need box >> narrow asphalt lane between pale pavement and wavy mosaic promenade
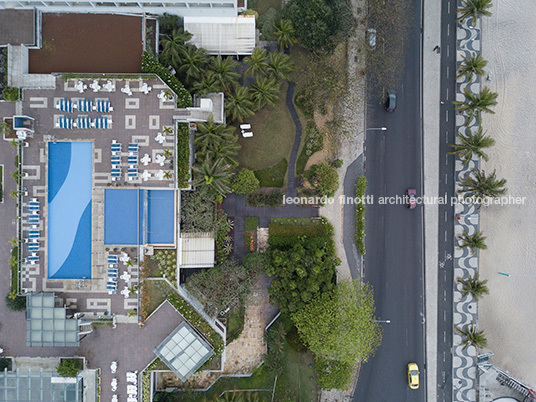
[437,0,456,402]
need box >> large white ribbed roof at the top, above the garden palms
[184,15,255,56]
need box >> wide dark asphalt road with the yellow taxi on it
[354,1,426,402]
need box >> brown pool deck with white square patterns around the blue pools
[16,77,180,314]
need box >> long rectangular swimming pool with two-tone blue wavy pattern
[48,142,93,279]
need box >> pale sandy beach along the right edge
[479,0,536,387]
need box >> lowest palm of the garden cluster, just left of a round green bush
[193,155,231,196]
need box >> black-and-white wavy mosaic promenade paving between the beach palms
[452,9,482,402]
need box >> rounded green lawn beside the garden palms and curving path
[237,82,296,170]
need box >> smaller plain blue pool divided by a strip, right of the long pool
[104,189,175,245]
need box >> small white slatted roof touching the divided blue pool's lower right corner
[181,232,215,268]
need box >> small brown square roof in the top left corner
[0,10,35,46]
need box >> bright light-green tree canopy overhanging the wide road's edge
[291,280,382,365]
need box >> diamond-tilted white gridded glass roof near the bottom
[154,321,214,381]
